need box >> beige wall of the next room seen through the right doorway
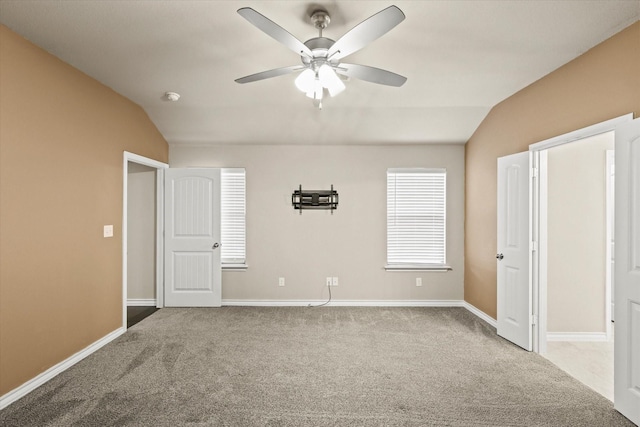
[547,132,614,333]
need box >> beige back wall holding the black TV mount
[169,145,464,301]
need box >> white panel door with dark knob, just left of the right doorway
[496,152,532,351]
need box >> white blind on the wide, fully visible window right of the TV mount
[387,169,447,267]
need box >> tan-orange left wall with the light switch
[0,26,168,395]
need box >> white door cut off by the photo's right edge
[614,119,640,425]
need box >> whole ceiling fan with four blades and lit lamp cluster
[236,6,407,108]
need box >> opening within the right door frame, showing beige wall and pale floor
[541,131,614,400]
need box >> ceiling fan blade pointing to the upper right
[327,6,404,60]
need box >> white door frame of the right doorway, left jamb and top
[529,113,633,354]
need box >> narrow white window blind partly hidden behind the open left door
[220,169,246,265]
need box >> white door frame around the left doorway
[122,151,169,329]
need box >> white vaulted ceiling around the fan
[0,0,640,145]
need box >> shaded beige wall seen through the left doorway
[127,162,156,299]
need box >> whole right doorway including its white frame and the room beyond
[530,115,631,400]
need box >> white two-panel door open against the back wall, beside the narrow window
[164,169,222,307]
